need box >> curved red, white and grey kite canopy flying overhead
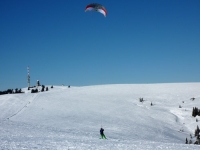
[85,3,107,17]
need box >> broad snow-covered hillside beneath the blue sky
[0,83,200,150]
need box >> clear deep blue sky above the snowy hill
[0,0,200,90]
